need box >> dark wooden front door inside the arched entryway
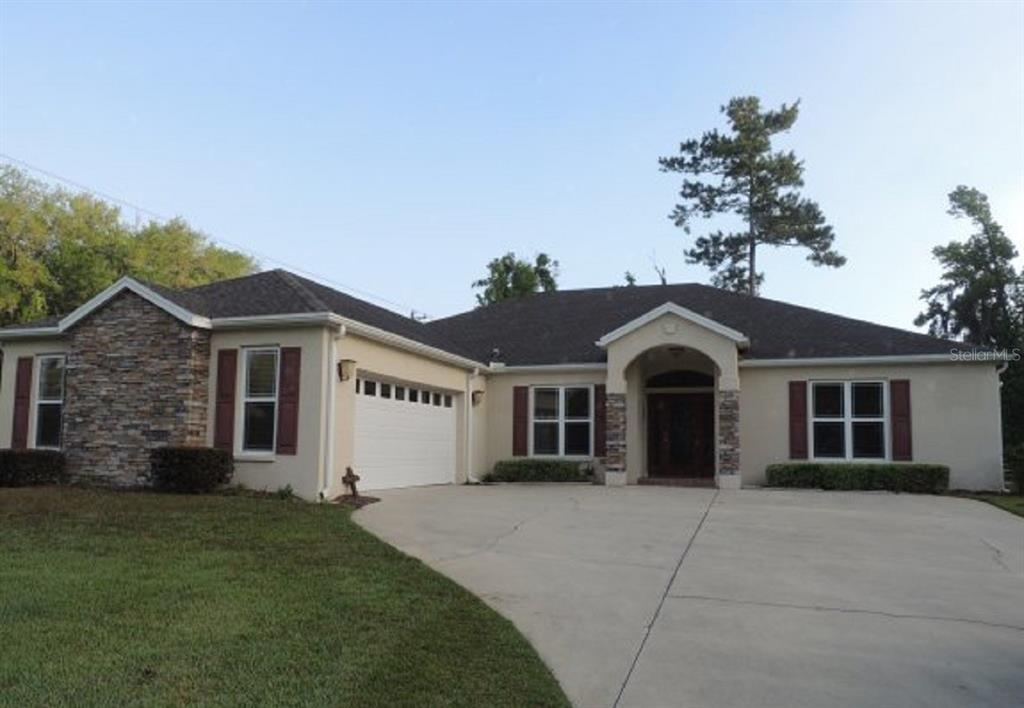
[647,392,715,477]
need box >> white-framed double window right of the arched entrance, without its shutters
[811,381,887,460]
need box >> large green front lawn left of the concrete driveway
[0,488,568,706]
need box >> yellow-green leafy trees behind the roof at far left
[0,165,257,325]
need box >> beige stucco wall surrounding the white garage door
[330,334,486,494]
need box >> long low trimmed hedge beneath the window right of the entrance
[767,462,949,494]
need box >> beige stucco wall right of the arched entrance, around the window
[739,363,1002,489]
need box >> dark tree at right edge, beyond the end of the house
[914,185,1024,447]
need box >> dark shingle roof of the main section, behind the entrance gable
[421,283,949,366]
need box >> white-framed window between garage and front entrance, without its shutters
[530,386,594,456]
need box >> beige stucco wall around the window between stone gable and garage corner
[207,327,330,499]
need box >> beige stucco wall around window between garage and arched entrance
[474,370,605,474]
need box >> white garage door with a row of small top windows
[354,380,456,490]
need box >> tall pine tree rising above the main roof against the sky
[658,96,846,295]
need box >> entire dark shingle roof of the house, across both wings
[5,269,950,366]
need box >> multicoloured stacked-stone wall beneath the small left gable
[62,292,210,486]
